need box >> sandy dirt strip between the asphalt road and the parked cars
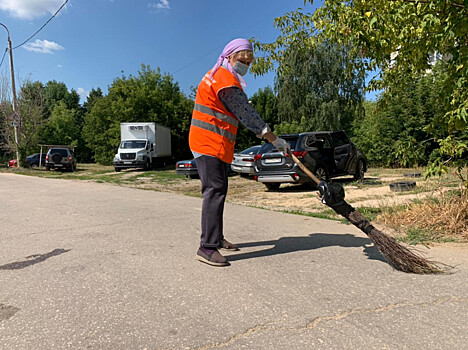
[125,174,458,213]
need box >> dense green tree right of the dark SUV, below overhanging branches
[355,71,443,167]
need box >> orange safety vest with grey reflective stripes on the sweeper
[189,67,242,163]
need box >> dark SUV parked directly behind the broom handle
[254,131,367,190]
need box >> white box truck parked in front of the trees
[113,123,171,171]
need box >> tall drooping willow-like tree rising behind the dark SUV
[275,38,364,132]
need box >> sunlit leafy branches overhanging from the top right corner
[256,0,468,186]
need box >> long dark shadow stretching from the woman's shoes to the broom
[225,233,385,262]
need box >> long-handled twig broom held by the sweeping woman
[288,152,447,274]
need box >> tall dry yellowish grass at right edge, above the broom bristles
[378,191,468,242]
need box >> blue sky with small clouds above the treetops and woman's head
[0,0,376,102]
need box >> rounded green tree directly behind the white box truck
[83,65,193,164]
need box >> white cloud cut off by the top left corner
[0,0,64,19]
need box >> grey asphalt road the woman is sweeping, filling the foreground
[0,174,468,350]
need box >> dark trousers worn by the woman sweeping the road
[195,156,228,248]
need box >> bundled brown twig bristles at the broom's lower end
[333,203,448,274]
